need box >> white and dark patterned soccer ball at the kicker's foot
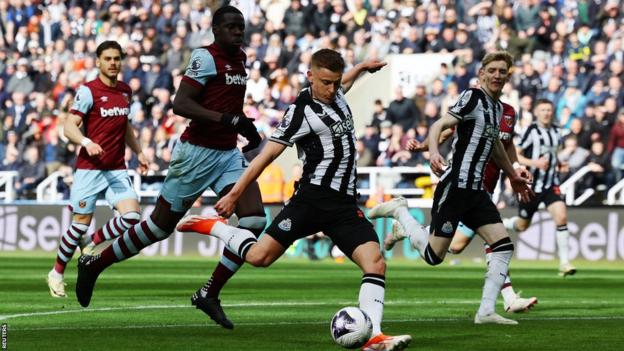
[331,307,373,349]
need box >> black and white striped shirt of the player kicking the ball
[270,88,356,196]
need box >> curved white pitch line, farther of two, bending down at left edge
[0,300,613,321]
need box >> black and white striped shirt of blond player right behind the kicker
[441,89,503,190]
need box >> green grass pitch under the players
[0,252,624,351]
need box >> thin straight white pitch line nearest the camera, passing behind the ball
[11,316,624,332]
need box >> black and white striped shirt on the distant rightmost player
[520,122,562,193]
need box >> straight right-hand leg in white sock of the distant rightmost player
[544,190,576,277]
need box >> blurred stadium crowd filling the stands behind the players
[0,0,624,202]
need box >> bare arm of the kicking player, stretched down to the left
[214,141,286,218]
